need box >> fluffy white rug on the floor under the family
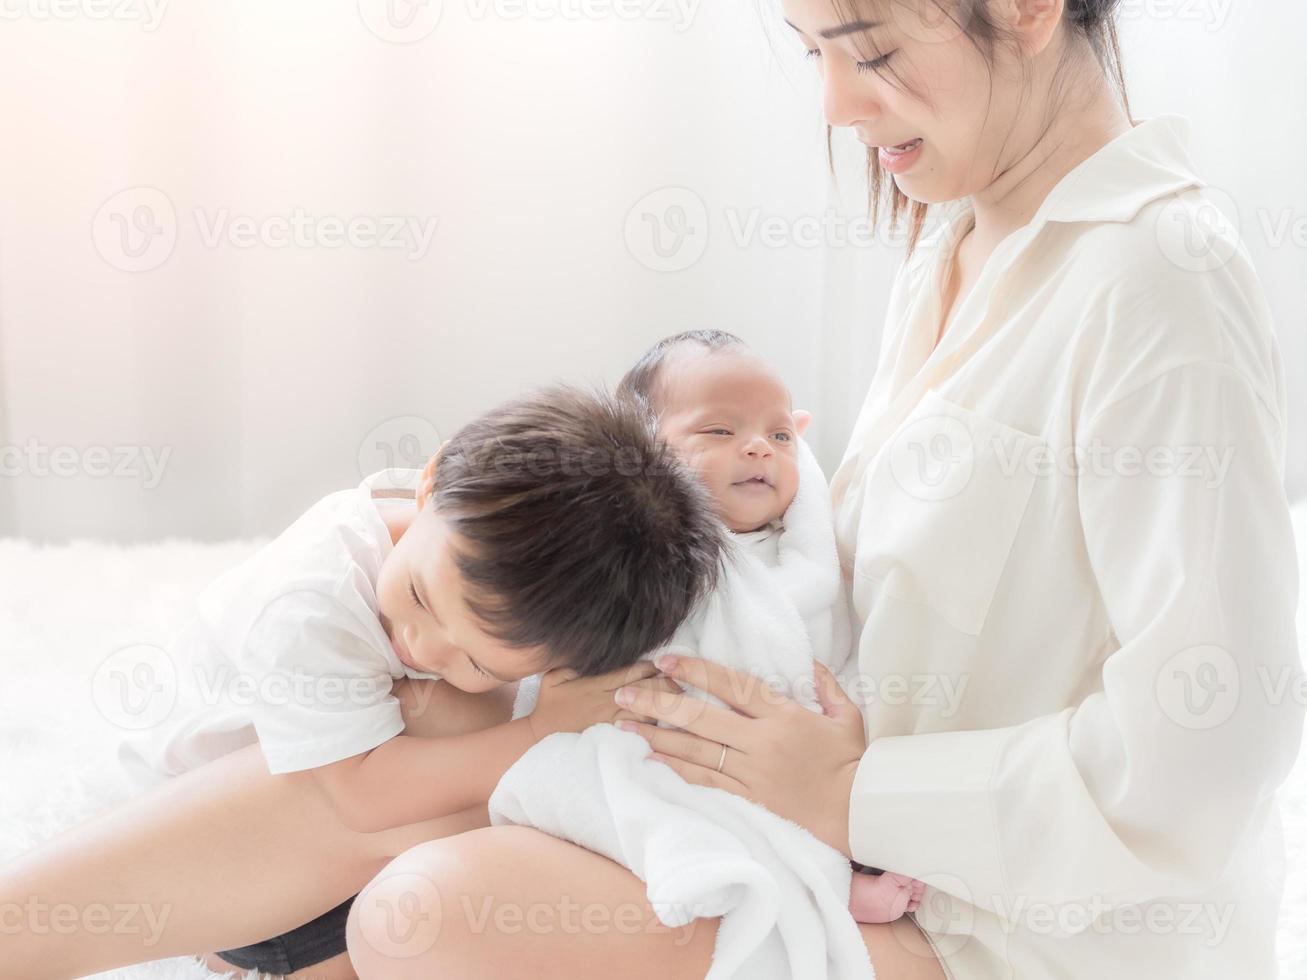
[0,514,1307,980]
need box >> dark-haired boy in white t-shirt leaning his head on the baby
[0,387,720,977]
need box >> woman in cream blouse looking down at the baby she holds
[349,0,1302,980]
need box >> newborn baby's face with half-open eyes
[659,348,809,532]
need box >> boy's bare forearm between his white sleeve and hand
[312,717,536,834]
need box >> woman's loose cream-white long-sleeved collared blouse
[831,116,1303,980]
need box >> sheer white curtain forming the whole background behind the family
[0,0,1307,541]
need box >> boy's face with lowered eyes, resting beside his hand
[376,498,549,694]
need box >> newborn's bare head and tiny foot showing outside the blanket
[617,331,924,923]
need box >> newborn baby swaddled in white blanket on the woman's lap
[490,331,923,961]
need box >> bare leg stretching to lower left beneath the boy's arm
[0,681,508,980]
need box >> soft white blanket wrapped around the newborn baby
[490,440,874,980]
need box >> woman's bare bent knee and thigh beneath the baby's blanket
[348,827,945,980]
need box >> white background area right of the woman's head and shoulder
[1121,0,1307,497]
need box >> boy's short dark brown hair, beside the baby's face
[433,385,721,676]
